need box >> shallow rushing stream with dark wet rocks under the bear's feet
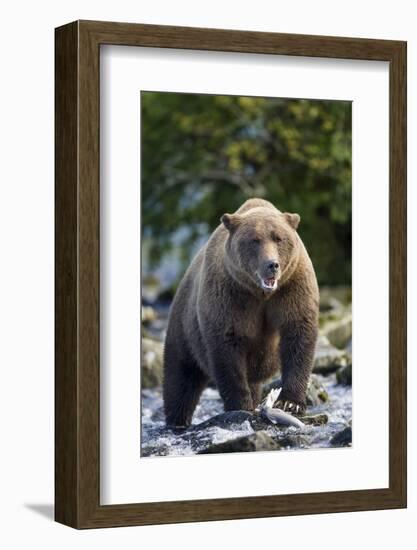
[141,374,352,456]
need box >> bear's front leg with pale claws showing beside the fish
[276,321,318,413]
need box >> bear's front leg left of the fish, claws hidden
[212,347,252,411]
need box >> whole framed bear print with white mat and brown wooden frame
[55,21,406,528]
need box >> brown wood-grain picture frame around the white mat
[55,21,407,529]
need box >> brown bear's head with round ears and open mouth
[221,208,300,294]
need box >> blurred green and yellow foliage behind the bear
[141,92,351,285]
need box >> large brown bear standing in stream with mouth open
[163,198,319,427]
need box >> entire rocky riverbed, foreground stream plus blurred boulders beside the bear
[140,291,352,457]
